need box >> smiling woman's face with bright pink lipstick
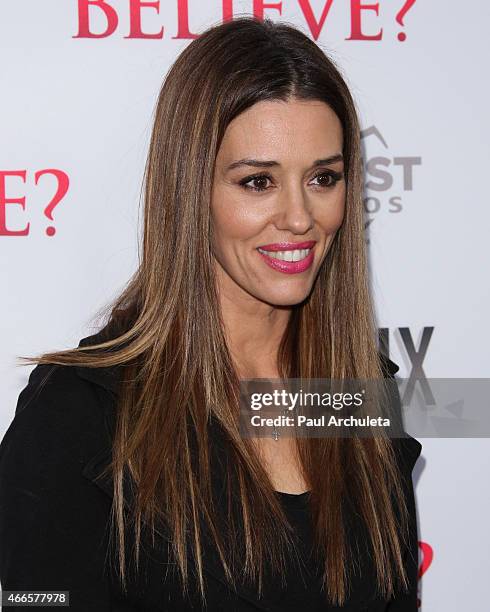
[211,100,346,306]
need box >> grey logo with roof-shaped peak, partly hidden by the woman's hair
[361,125,422,242]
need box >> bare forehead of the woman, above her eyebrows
[218,100,343,162]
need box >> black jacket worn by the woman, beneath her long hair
[0,332,422,612]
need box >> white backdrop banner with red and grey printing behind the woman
[0,0,490,612]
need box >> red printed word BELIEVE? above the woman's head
[73,0,416,42]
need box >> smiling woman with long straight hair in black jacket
[0,17,421,612]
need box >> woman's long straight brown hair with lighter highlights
[21,17,407,604]
